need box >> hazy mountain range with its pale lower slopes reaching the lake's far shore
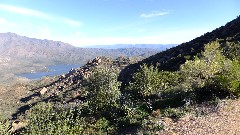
[0,33,159,77]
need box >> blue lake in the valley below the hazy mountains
[17,64,81,80]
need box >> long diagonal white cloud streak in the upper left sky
[0,4,83,27]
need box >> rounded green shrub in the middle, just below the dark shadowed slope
[128,64,180,97]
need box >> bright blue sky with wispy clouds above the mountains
[0,0,240,46]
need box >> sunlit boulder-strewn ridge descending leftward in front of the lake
[13,57,141,117]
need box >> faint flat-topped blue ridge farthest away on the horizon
[83,44,177,51]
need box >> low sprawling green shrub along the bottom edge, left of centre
[20,103,116,135]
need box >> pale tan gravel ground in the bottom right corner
[159,99,240,135]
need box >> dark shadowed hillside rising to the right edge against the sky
[120,16,240,82]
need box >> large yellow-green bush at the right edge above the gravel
[180,41,240,100]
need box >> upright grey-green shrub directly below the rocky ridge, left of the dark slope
[85,68,121,116]
